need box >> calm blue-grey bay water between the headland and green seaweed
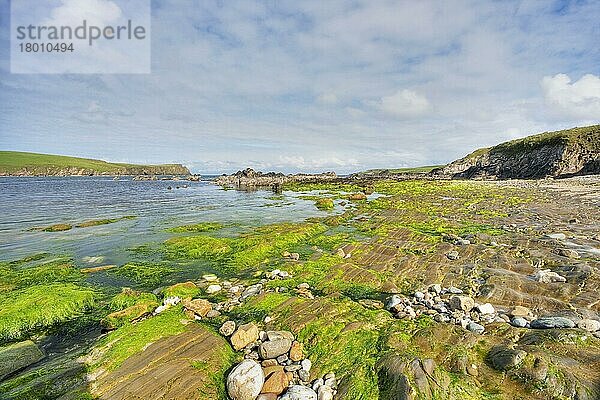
[0,177,327,266]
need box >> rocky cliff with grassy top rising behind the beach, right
[432,125,600,179]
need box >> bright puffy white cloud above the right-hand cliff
[541,74,600,120]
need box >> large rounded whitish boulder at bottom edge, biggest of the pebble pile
[227,360,265,400]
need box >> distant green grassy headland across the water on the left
[0,151,190,176]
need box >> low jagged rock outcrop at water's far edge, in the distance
[215,168,337,187]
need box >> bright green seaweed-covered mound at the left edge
[0,283,94,342]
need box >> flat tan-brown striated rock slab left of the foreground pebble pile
[93,324,229,400]
